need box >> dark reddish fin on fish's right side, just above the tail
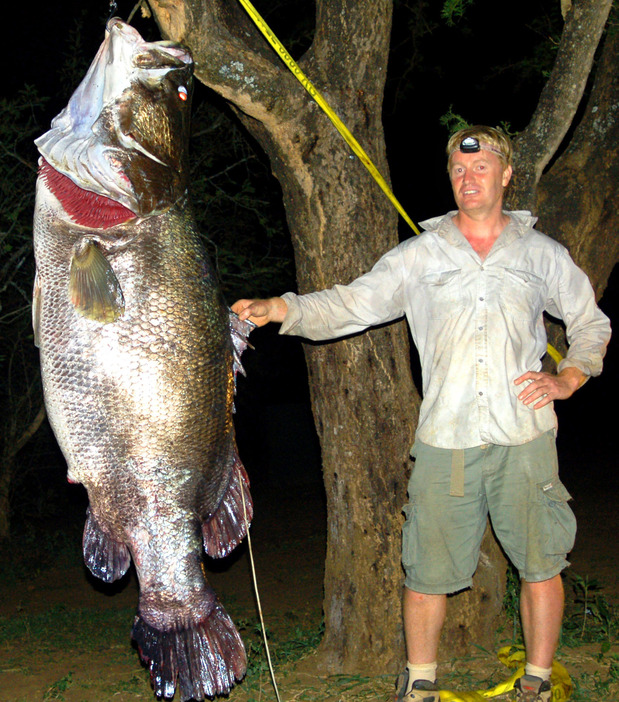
[202,453,254,558]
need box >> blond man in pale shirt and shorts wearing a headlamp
[233,127,610,702]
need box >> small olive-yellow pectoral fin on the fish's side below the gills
[69,239,125,324]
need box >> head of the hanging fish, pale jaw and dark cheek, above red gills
[35,18,193,218]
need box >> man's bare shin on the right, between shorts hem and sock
[520,575,564,668]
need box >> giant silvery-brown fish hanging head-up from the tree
[33,19,252,700]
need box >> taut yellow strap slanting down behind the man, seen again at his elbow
[239,0,563,364]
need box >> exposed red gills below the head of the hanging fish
[39,158,137,229]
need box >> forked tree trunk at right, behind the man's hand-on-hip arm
[509,6,619,371]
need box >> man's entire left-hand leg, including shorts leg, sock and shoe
[396,441,488,702]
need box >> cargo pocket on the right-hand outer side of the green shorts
[537,477,576,556]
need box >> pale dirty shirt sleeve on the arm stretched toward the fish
[280,247,405,341]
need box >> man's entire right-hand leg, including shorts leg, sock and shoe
[485,432,576,702]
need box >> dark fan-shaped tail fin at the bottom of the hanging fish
[132,602,247,702]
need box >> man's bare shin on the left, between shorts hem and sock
[404,587,447,665]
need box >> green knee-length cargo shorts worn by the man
[402,432,576,594]
